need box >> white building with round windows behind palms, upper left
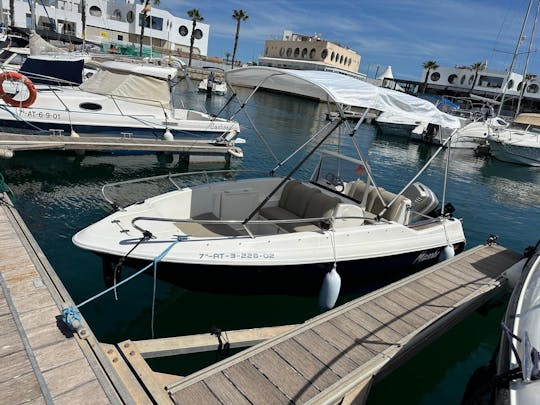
[1,0,210,55]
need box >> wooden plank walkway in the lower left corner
[0,193,135,404]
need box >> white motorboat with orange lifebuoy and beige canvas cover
[0,61,239,139]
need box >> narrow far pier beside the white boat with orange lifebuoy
[0,132,242,162]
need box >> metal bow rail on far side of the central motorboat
[101,169,272,211]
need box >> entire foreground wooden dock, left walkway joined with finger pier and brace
[0,185,520,404]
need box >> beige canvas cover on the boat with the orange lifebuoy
[80,64,171,108]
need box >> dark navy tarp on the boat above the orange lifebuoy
[20,58,84,85]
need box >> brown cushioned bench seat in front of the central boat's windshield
[260,180,341,232]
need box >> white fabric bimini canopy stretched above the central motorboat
[225,66,460,128]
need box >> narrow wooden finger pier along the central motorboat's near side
[167,241,520,404]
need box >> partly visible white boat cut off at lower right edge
[496,241,540,405]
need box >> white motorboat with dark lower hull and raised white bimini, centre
[73,67,465,294]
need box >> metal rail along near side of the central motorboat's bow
[131,215,384,238]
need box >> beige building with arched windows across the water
[259,31,365,77]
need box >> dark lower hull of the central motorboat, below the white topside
[98,243,465,295]
